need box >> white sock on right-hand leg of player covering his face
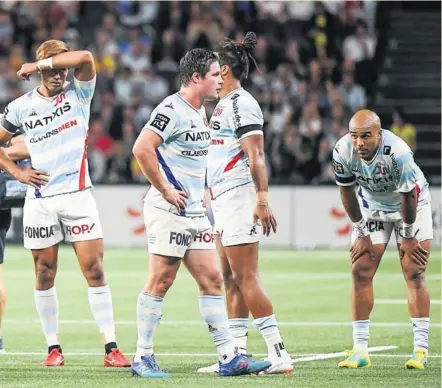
[87,285,115,344]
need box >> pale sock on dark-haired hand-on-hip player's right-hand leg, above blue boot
[199,295,236,363]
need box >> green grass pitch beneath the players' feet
[0,247,441,388]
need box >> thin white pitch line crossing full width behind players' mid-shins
[4,318,441,328]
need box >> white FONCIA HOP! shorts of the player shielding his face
[23,190,103,249]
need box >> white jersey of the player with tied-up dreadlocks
[207,88,264,198]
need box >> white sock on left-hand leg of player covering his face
[34,286,60,347]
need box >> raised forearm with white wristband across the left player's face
[17,50,96,81]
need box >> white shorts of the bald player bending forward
[351,203,433,244]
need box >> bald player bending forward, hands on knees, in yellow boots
[333,109,433,369]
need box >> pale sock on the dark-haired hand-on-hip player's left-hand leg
[134,291,163,362]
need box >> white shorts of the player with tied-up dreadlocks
[211,183,259,247]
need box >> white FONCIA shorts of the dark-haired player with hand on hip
[143,202,216,258]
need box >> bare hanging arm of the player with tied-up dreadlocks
[240,135,277,236]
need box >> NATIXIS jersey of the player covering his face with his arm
[1,77,96,198]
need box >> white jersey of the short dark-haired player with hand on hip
[144,93,210,217]
